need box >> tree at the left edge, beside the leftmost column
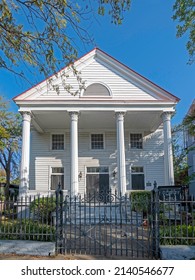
[0,97,22,197]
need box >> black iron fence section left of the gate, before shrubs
[0,196,56,241]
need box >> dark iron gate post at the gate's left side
[55,184,63,254]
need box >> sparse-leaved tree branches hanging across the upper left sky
[0,0,131,82]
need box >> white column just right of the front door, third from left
[116,112,126,195]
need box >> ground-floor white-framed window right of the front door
[131,166,145,190]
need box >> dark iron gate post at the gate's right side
[152,182,160,259]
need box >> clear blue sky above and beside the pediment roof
[0,0,195,124]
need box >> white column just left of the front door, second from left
[69,112,79,195]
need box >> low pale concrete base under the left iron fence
[0,240,55,256]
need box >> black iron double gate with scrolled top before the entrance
[56,190,154,259]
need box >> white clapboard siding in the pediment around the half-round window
[35,60,156,100]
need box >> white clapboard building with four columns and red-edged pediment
[14,48,179,194]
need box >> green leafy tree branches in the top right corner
[173,0,195,63]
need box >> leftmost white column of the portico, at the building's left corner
[20,112,31,195]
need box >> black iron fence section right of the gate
[156,187,195,245]
